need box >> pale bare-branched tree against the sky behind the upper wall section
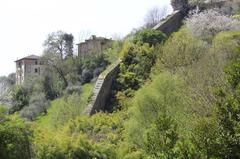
[144,6,167,28]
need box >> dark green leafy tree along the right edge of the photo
[217,54,240,159]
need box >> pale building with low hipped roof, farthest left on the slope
[15,55,44,85]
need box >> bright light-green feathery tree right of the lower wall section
[126,72,185,149]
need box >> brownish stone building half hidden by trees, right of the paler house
[77,35,112,57]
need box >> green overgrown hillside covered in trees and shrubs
[0,1,240,159]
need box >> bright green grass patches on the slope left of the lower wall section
[35,83,94,129]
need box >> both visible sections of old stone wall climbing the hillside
[85,11,188,115]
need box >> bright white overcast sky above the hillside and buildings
[0,0,171,76]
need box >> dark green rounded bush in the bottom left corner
[0,117,32,159]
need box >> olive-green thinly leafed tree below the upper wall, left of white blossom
[160,28,206,72]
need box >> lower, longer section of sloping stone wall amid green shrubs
[85,60,121,115]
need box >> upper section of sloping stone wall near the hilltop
[153,10,186,35]
